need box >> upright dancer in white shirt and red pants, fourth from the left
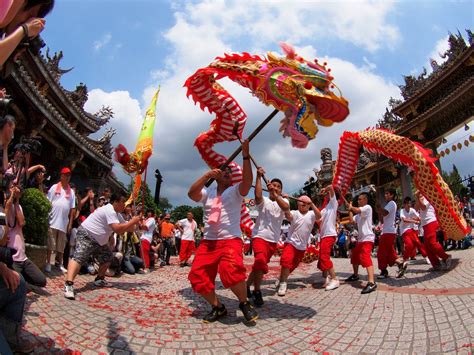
[318,185,339,291]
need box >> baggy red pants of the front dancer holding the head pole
[188,238,246,295]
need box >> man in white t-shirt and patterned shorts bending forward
[64,193,141,300]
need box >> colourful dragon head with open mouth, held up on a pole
[255,43,349,148]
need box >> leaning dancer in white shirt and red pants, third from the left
[275,195,321,296]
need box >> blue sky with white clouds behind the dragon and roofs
[42,0,474,205]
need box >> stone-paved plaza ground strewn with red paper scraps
[24,248,474,354]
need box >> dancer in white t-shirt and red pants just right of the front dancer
[247,168,290,307]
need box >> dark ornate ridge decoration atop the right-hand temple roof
[399,30,473,100]
